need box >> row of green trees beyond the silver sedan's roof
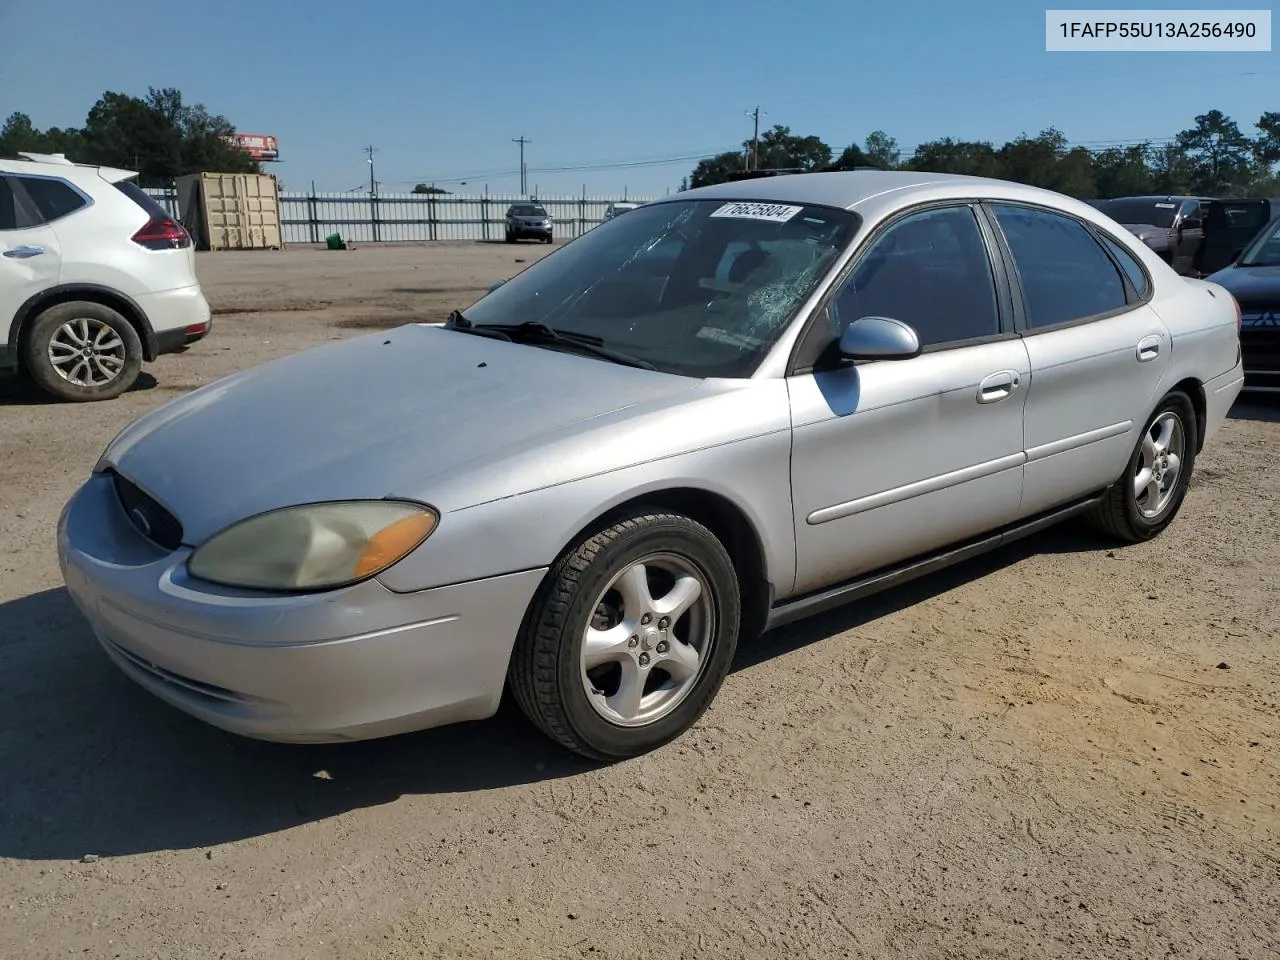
[681,110,1280,200]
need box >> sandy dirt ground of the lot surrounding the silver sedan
[0,243,1280,960]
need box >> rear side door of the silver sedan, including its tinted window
[988,202,1171,517]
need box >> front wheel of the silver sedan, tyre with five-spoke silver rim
[508,511,741,760]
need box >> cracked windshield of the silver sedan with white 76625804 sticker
[466,200,858,376]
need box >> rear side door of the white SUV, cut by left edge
[0,175,61,344]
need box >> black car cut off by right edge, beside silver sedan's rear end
[1208,216,1280,393]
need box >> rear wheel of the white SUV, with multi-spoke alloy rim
[22,301,142,402]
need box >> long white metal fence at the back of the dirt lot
[147,188,654,243]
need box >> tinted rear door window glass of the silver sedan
[992,204,1128,329]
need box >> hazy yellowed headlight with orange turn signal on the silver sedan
[187,500,439,590]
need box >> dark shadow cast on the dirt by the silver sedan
[0,527,1101,860]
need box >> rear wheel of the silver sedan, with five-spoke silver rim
[1089,390,1199,543]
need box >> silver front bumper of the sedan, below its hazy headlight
[58,476,545,742]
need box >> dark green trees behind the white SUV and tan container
[0,87,261,187]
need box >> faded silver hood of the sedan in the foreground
[100,325,701,544]
